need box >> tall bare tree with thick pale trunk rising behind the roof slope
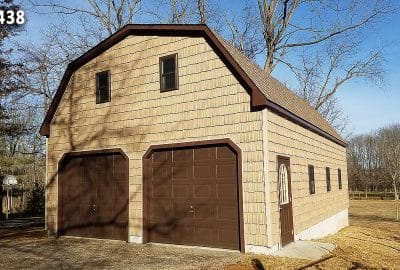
[257,0,393,73]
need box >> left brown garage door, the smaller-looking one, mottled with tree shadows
[59,153,129,240]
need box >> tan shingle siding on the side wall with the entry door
[266,111,348,244]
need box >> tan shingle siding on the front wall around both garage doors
[47,36,266,245]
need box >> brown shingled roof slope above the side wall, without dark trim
[213,31,344,142]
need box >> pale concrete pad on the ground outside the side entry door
[271,241,336,260]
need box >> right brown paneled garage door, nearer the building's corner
[145,146,240,249]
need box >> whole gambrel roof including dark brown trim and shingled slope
[40,24,346,146]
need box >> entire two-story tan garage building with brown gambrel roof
[40,25,348,253]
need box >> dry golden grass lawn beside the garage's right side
[225,200,400,270]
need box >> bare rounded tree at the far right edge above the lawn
[377,124,400,200]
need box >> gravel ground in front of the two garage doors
[0,226,245,270]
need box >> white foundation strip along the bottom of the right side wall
[295,208,349,240]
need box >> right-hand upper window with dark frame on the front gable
[160,53,178,92]
